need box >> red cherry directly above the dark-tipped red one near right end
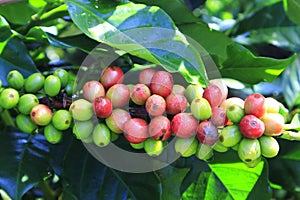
[244,94,265,118]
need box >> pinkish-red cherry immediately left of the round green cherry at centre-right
[166,94,188,115]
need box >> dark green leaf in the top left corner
[0,1,36,25]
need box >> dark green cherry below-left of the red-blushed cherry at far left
[16,114,38,134]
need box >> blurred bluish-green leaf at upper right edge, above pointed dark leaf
[236,26,300,52]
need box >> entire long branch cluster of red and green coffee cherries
[0,66,285,167]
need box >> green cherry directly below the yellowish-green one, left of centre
[73,121,94,140]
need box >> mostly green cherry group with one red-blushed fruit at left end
[0,68,76,143]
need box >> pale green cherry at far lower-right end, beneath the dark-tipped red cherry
[258,135,279,158]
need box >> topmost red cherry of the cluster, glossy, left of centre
[100,66,124,89]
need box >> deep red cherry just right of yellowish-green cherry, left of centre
[93,97,113,118]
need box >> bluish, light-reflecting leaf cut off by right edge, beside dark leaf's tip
[282,56,300,109]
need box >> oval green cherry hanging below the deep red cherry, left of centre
[93,123,111,147]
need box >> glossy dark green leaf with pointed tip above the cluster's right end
[220,44,296,84]
